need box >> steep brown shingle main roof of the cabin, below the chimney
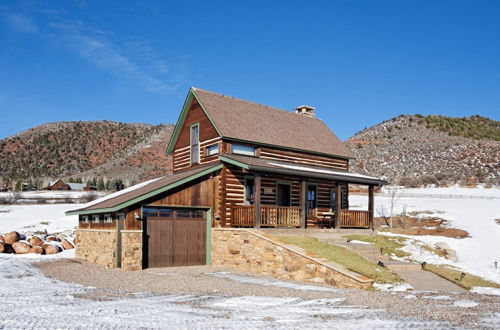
[193,88,355,158]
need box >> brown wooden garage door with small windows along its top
[145,208,207,267]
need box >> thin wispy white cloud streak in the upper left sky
[0,7,184,93]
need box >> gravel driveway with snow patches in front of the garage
[36,259,500,328]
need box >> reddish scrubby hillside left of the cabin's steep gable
[0,121,173,187]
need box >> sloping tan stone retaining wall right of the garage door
[212,228,372,289]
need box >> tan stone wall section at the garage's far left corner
[75,229,116,267]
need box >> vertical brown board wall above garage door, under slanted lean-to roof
[125,173,220,230]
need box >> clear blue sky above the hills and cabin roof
[0,0,500,139]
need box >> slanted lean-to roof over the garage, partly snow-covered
[67,163,220,214]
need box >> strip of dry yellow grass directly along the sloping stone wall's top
[276,236,403,283]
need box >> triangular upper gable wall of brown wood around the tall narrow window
[173,99,221,172]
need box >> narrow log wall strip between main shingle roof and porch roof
[258,147,349,171]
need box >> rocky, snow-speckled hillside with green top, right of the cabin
[347,115,500,186]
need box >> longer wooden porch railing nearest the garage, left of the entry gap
[232,205,301,227]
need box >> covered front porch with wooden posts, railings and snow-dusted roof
[221,155,387,229]
